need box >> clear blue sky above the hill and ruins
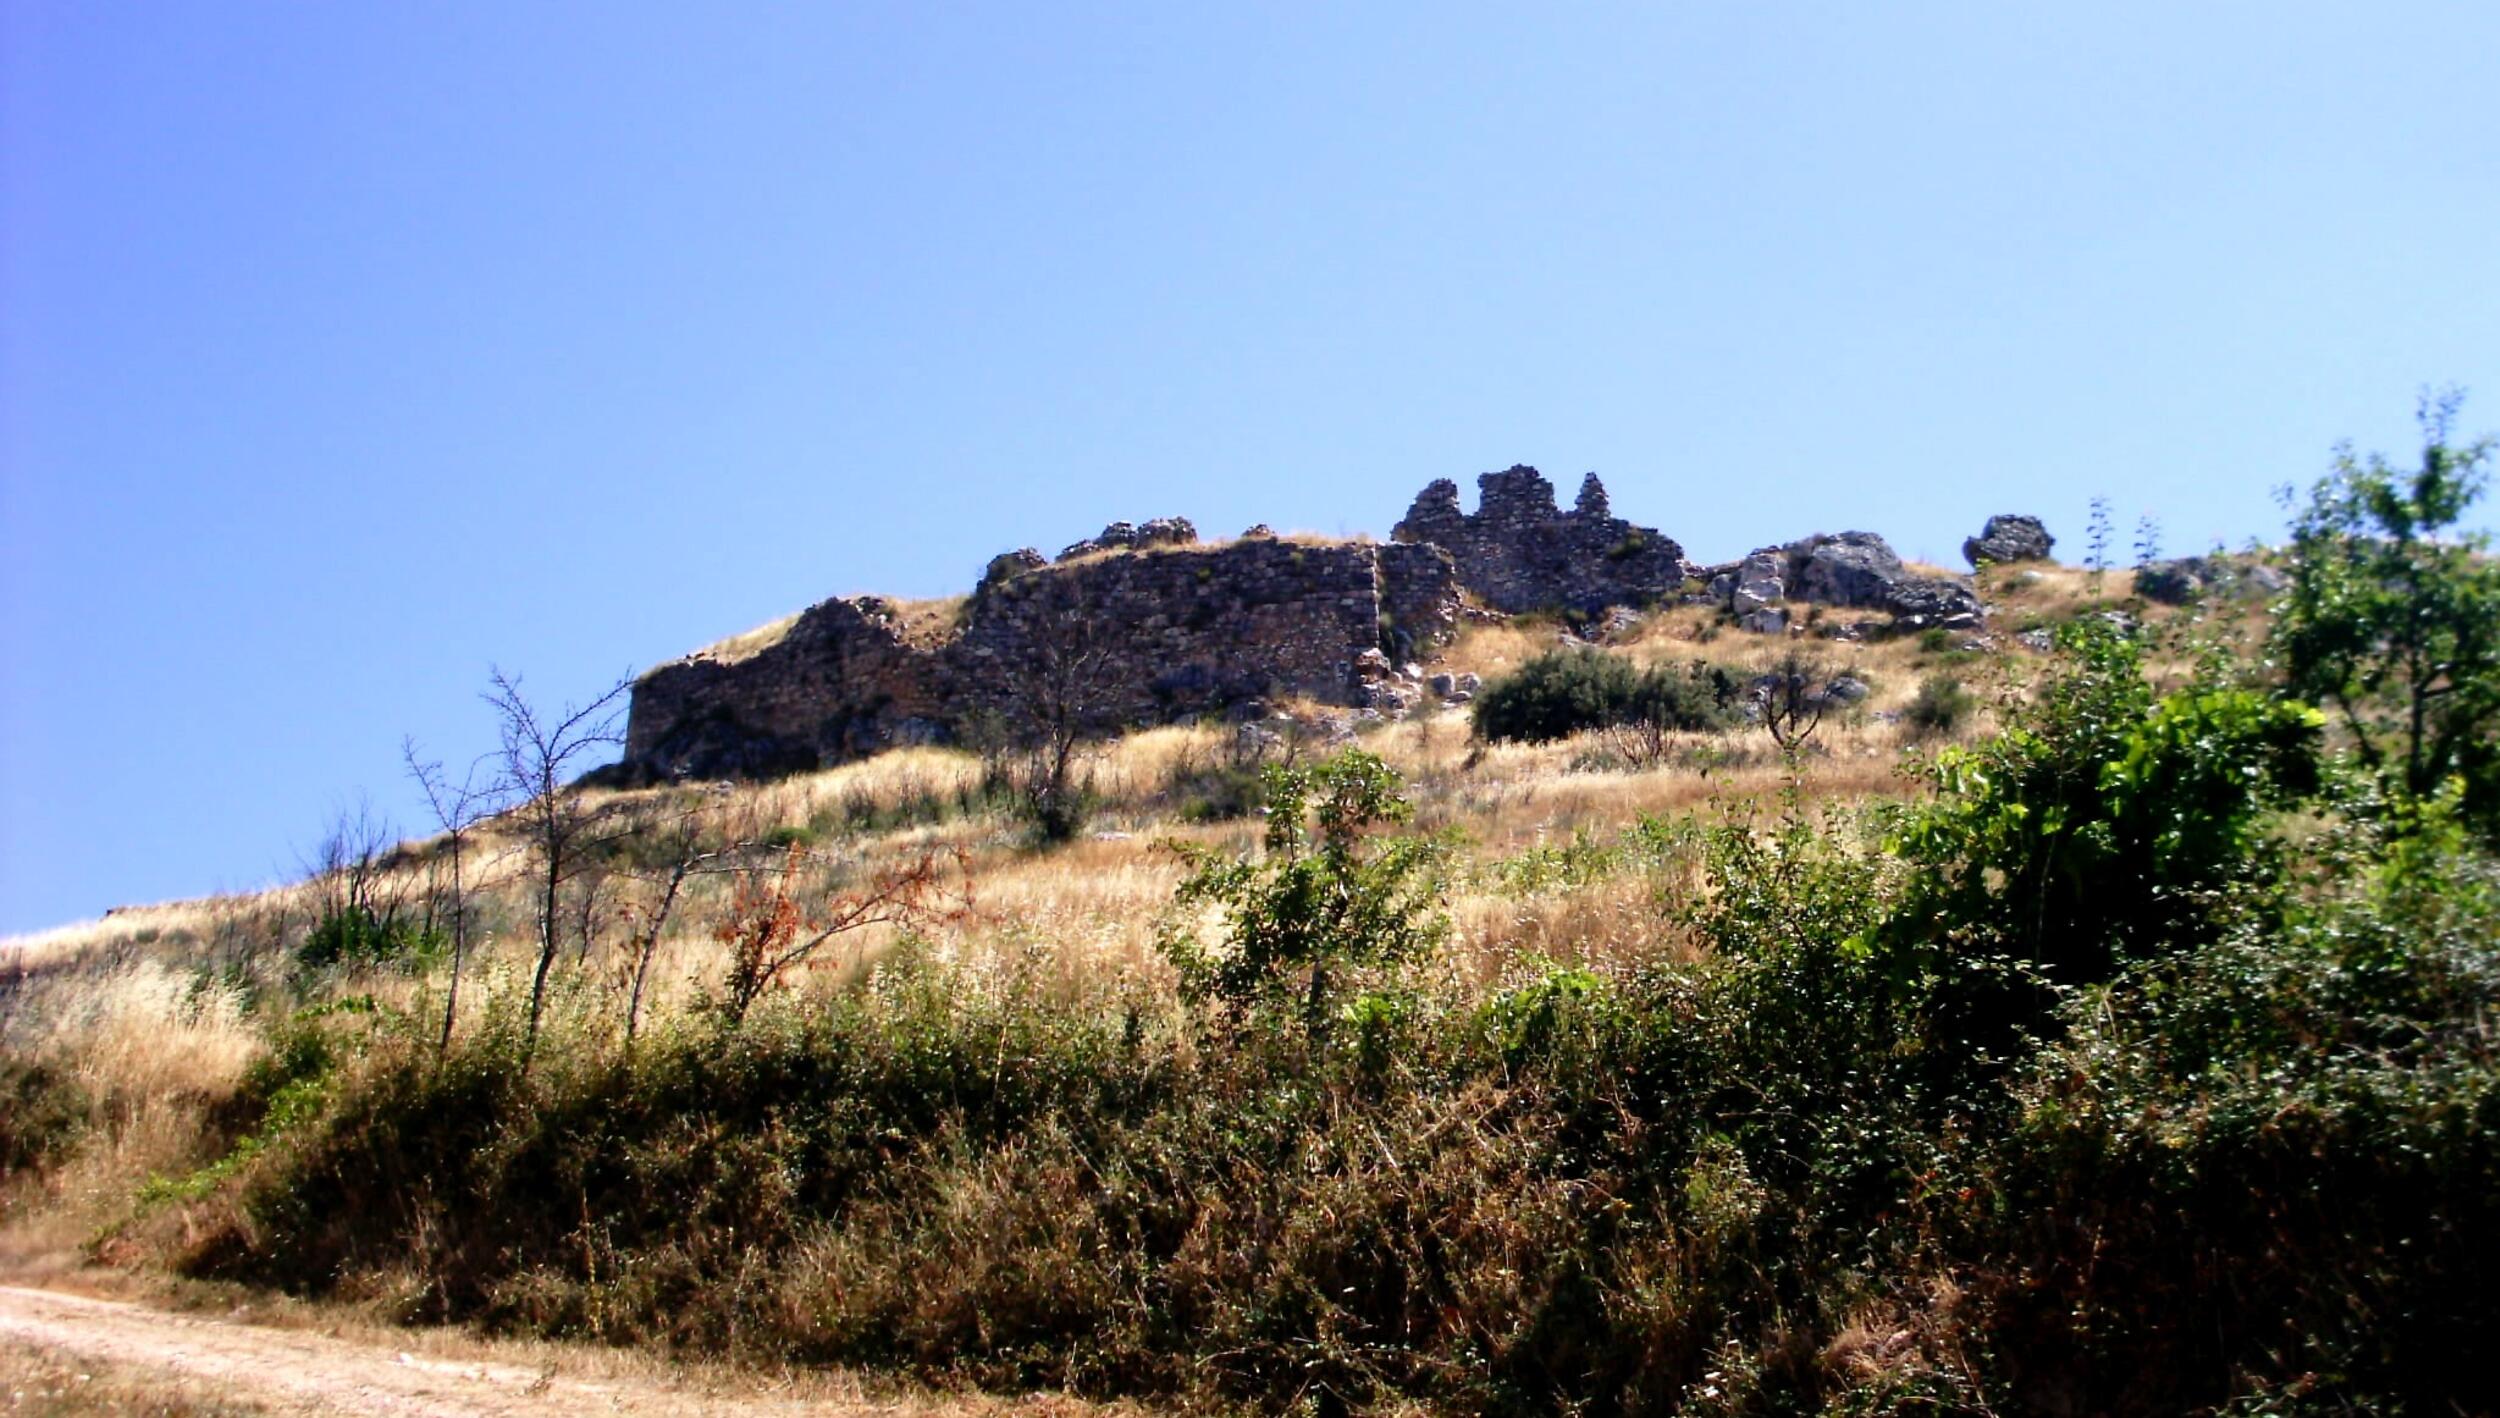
[0,0,2500,930]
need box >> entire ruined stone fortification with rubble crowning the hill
[613,468,2030,783]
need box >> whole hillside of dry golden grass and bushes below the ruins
[0,423,2500,1413]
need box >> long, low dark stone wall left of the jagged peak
[625,538,1458,778]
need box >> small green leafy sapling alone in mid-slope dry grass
[1158,748,1448,1033]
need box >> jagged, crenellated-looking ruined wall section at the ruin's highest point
[1390,468,1693,615]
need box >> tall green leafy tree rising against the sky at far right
[2273,390,2500,828]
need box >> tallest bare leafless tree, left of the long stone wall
[485,670,633,1050]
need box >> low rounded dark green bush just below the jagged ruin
[1475,645,1743,743]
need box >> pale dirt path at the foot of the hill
[0,1285,1105,1418]
